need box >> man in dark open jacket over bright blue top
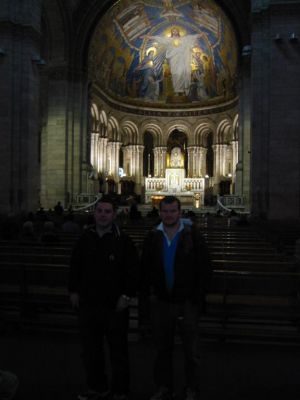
[142,196,210,400]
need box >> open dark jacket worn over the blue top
[141,226,211,308]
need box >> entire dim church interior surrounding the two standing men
[0,0,300,400]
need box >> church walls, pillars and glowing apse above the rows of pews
[0,0,300,219]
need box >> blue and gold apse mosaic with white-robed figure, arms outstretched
[89,0,237,106]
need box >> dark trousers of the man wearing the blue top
[150,298,198,390]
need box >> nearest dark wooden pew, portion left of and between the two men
[0,258,138,340]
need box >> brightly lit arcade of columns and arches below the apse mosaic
[88,103,238,204]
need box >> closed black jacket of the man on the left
[68,225,138,308]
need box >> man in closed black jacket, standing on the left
[69,195,138,400]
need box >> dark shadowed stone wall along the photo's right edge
[251,1,300,219]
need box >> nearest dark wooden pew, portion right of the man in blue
[199,269,300,341]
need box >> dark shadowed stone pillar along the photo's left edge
[0,0,42,213]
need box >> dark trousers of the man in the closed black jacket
[78,306,129,394]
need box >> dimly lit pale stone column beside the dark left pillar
[41,66,77,207]
